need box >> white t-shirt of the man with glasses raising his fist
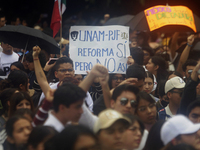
[38,82,93,112]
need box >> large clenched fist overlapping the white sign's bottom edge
[90,64,108,77]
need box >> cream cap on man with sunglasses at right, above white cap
[165,77,185,94]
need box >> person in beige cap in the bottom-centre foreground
[94,109,130,150]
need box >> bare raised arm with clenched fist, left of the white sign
[33,46,50,97]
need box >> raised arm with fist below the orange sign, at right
[176,35,194,74]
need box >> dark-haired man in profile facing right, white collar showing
[44,83,86,132]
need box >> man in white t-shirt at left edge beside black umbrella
[0,41,19,75]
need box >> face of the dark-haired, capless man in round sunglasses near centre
[111,91,136,115]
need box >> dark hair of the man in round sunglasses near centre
[112,84,139,101]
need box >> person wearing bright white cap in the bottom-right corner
[161,115,200,150]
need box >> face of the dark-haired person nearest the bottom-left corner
[9,119,32,146]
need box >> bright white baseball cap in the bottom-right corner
[161,115,200,145]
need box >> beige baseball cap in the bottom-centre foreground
[94,109,131,133]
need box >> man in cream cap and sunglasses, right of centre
[158,77,185,120]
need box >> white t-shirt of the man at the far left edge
[0,52,19,75]
